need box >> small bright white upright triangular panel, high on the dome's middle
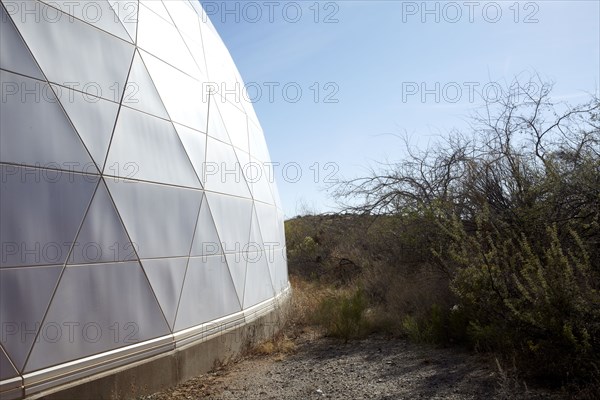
[123,51,169,119]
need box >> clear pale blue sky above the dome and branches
[202,1,600,217]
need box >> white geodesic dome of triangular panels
[0,0,288,397]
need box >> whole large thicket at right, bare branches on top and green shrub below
[328,76,600,386]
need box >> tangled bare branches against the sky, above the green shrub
[333,76,600,238]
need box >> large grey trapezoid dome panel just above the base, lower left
[25,262,170,372]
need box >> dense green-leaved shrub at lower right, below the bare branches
[445,217,600,380]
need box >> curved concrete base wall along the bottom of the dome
[11,288,291,400]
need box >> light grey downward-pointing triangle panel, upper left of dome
[52,85,119,169]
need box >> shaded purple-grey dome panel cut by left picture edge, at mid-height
[0,164,99,267]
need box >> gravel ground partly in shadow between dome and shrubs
[143,335,561,400]
